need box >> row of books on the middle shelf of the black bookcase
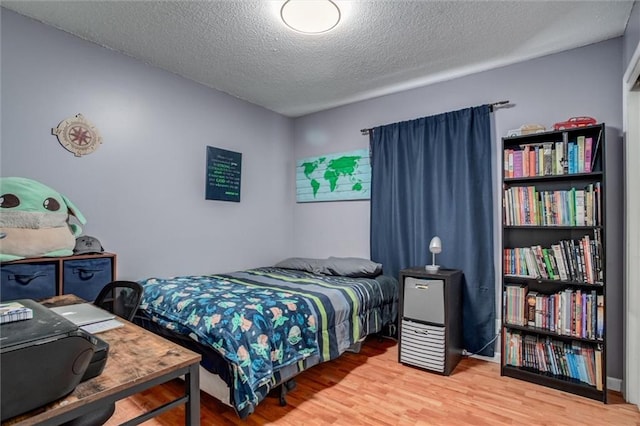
[503,229,604,285]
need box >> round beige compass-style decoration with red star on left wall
[51,114,102,157]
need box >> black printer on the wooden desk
[0,299,99,421]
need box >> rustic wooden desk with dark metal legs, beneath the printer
[2,295,200,426]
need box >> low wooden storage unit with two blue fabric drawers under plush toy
[0,253,116,301]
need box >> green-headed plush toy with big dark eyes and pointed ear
[0,177,86,262]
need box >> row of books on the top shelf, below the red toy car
[504,136,599,178]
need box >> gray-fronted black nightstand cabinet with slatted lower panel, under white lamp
[398,266,462,376]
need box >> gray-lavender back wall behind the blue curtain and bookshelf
[293,38,623,378]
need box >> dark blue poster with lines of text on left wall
[206,146,242,202]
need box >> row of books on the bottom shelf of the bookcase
[504,330,603,390]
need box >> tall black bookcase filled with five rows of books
[500,124,607,403]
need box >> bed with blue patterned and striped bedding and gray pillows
[135,258,398,418]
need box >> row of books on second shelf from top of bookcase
[503,182,602,226]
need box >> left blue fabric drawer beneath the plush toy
[0,263,57,301]
